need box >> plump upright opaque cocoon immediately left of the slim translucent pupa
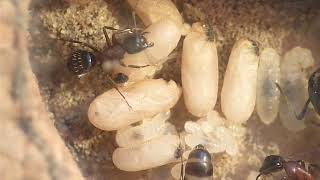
[221,39,259,123]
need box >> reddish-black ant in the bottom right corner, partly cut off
[256,155,318,180]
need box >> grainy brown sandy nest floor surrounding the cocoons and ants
[29,0,320,180]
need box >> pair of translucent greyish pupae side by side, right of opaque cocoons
[257,47,314,131]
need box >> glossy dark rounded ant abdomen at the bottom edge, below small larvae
[180,144,213,180]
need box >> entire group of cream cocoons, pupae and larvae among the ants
[88,0,313,178]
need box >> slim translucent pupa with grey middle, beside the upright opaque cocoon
[256,48,280,124]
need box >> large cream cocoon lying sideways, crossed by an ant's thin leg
[88,79,181,131]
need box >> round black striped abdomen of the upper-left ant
[67,50,96,77]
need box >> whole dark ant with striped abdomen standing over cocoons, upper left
[59,12,153,108]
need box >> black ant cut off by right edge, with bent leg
[275,68,320,120]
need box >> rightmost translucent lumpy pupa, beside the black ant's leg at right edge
[280,47,314,131]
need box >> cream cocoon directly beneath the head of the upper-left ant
[114,20,181,82]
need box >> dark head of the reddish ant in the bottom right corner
[259,155,285,174]
